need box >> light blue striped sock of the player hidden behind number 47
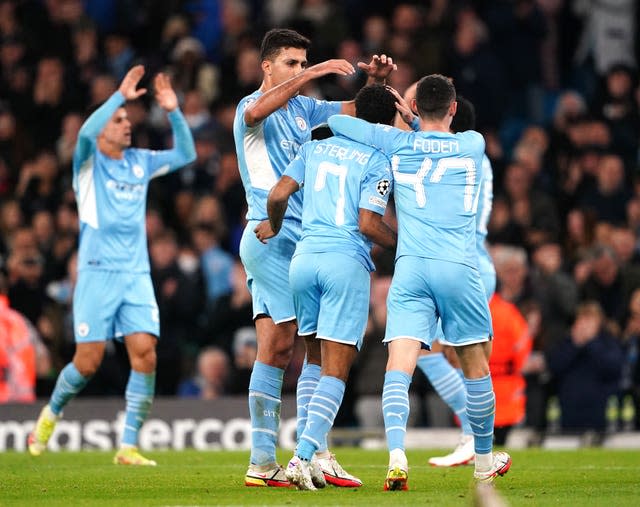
[418,352,473,435]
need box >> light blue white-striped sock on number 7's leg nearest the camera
[296,375,345,460]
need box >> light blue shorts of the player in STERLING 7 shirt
[289,252,371,350]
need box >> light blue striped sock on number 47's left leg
[382,370,411,452]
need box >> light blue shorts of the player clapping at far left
[73,270,160,343]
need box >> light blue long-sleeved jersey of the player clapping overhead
[73,92,196,273]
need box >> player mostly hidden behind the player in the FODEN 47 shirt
[396,88,496,467]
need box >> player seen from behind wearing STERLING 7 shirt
[258,85,396,490]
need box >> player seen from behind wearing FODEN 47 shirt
[329,74,511,490]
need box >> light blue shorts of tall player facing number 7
[240,219,301,324]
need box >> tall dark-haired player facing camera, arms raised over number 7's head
[233,29,394,487]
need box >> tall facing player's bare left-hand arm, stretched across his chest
[244,60,355,127]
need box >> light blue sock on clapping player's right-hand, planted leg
[121,370,156,446]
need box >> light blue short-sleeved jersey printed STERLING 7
[284,136,392,271]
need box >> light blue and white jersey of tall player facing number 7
[233,90,342,221]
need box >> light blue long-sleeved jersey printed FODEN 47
[329,115,485,267]
